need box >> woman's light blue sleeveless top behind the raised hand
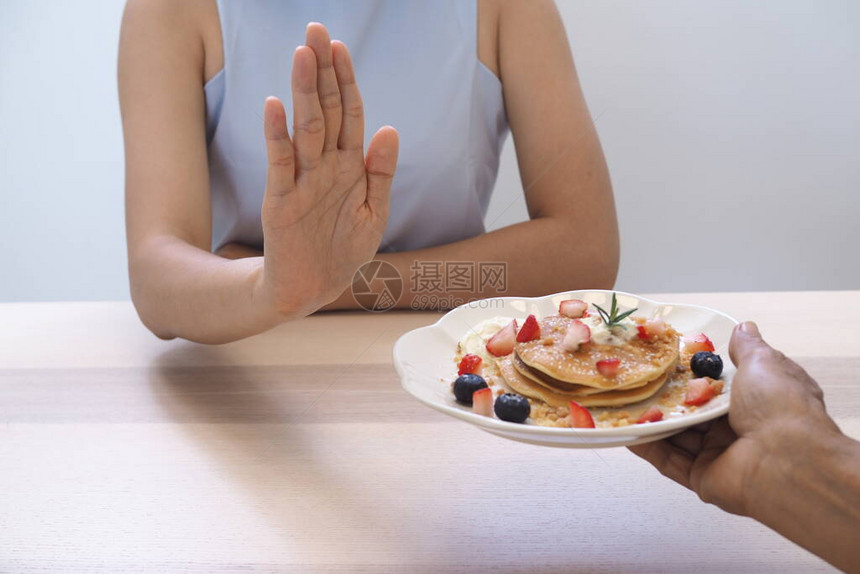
[205,0,508,251]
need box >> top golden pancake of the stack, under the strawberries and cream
[514,315,679,391]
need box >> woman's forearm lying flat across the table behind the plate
[325,217,618,309]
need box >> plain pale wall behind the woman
[0,0,860,301]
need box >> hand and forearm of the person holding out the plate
[630,322,860,572]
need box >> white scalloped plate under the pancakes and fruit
[394,290,738,448]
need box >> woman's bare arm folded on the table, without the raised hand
[326,0,619,309]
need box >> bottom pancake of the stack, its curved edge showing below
[498,356,669,408]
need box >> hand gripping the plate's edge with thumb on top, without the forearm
[630,322,839,515]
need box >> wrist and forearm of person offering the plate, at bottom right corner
[750,429,860,572]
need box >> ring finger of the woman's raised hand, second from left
[292,46,325,170]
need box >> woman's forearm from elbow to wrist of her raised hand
[129,237,283,344]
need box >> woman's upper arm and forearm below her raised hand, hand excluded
[118,0,275,342]
